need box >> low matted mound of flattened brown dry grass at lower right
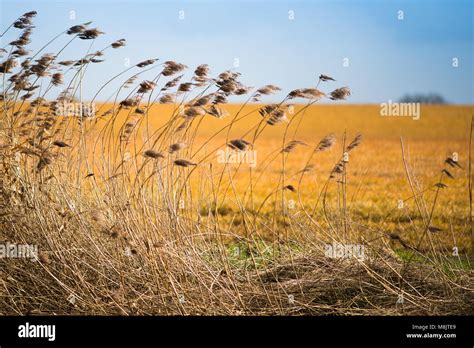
[247,254,474,315]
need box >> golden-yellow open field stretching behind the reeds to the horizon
[66,104,474,252]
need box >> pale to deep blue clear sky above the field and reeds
[0,0,474,104]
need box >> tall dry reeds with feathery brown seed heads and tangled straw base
[0,11,474,315]
